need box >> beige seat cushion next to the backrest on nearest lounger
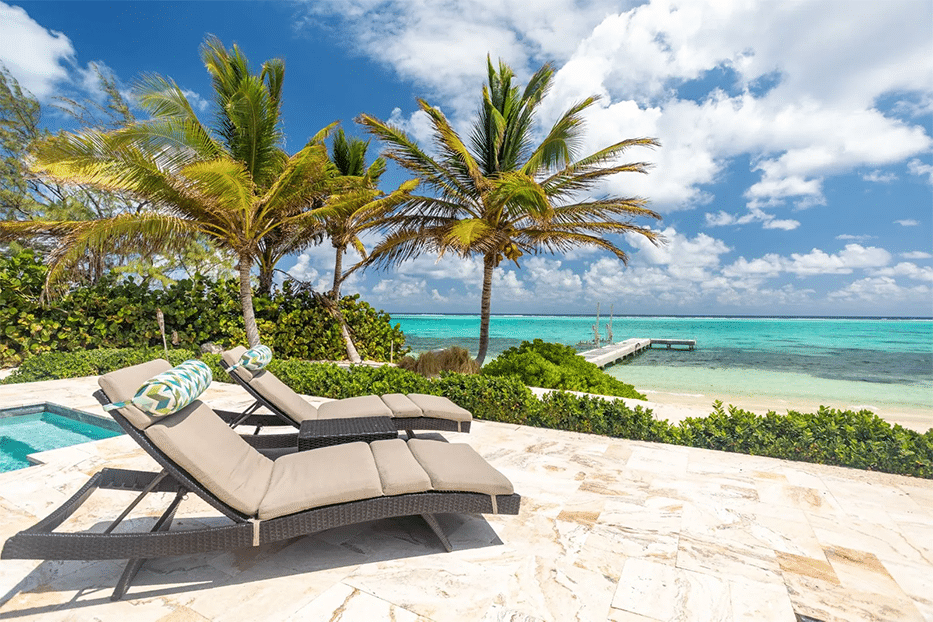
[259,443,382,520]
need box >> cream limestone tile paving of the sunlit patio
[0,378,933,622]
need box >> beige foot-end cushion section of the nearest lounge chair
[408,438,514,495]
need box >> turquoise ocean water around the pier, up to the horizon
[392,314,933,410]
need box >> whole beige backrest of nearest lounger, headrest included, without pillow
[98,359,272,516]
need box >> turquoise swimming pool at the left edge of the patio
[0,402,123,472]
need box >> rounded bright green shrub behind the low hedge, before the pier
[482,339,646,400]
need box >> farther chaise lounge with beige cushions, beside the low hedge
[220,346,473,438]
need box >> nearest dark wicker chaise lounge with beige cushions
[0,359,521,600]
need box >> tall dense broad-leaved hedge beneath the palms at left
[0,251,408,367]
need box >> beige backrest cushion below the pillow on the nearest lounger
[146,400,272,516]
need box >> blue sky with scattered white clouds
[0,0,933,316]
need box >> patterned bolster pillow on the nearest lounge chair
[104,360,213,417]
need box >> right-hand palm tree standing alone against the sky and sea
[357,58,660,365]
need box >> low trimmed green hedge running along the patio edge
[5,349,933,478]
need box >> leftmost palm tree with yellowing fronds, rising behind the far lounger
[0,37,333,346]
